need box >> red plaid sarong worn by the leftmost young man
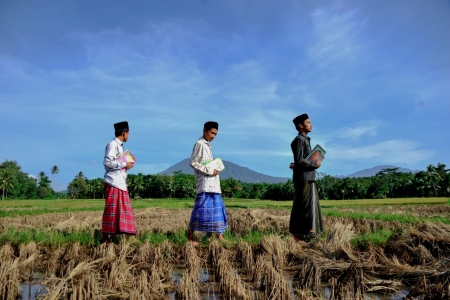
[102,183,136,235]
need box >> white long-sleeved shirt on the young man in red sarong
[103,138,128,191]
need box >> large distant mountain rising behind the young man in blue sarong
[158,158,290,183]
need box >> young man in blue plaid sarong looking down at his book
[188,121,228,246]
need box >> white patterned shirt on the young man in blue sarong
[189,137,222,194]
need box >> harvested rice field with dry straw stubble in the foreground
[0,204,450,300]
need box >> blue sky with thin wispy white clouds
[0,0,450,189]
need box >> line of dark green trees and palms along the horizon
[0,160,450,200]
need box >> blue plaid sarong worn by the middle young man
[189,192,228,233]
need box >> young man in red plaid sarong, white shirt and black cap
[102,122,136,242]
